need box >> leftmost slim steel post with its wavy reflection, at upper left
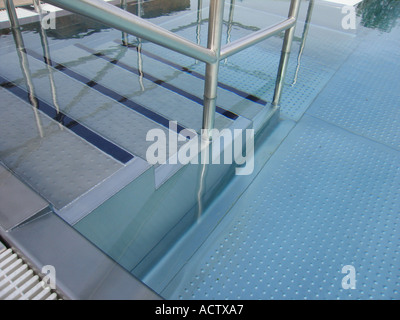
[5,0,44,137]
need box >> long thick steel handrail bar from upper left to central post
[45,0,218,63]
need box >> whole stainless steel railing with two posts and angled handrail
[6,0,300,138]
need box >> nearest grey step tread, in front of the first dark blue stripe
[0,82,123,209]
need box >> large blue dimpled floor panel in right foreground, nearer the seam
[163,116,400,299]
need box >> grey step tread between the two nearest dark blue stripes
[0,48,185,159]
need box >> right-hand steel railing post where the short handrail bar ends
[272,0,300,106]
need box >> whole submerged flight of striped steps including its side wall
[0,11,278,276]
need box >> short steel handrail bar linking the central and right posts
[220,17,296,60]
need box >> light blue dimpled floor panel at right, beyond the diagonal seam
[309,27,400,150]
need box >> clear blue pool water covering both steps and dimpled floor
[0,0,400,299]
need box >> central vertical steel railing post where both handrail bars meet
[203,0,224,138]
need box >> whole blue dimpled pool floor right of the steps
[159,16,400,299]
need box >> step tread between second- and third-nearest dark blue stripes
[52,45,237,132]
